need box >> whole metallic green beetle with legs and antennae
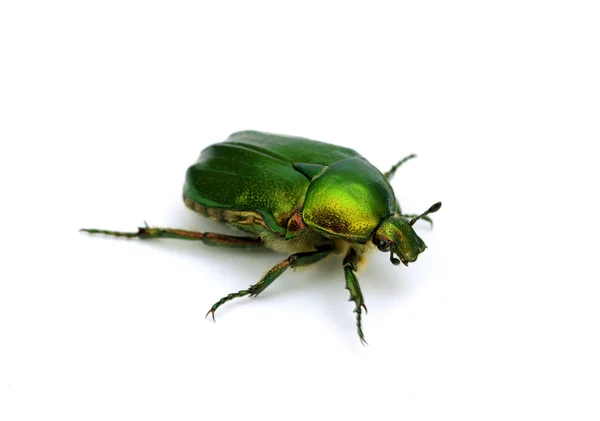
[82,131,442,343]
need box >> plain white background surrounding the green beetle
[0,0,600,420]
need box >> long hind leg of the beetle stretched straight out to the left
[80,224,263,247]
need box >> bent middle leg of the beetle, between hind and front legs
[206,248,333,320]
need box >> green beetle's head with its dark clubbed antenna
[373,202,442,266]
